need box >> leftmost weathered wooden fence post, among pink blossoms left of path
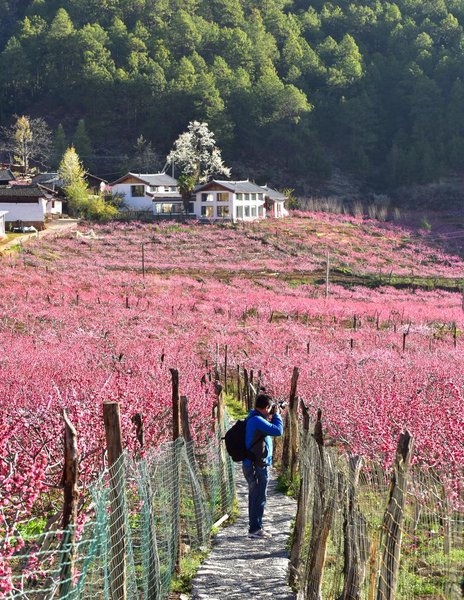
[60,410,79,598]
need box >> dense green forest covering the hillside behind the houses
[0,0,464,190]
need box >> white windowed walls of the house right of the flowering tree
[195,190,266,221]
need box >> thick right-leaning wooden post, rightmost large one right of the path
[376,431,414,600]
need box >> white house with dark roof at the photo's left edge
[0,184,58,229]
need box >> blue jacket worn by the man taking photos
[243,409,284,467]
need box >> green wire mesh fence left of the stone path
[0,432,235,600]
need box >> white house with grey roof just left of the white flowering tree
[110,173,183,215]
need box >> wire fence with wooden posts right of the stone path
[291,431,464,600]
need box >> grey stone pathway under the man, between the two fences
[192,465,296,600]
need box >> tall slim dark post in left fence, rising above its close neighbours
[169,369,182,572]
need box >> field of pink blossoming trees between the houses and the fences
[0,214,464,572]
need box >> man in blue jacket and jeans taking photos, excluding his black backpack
[242,393,284,538]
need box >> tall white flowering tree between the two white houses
[166,121,230,212]
